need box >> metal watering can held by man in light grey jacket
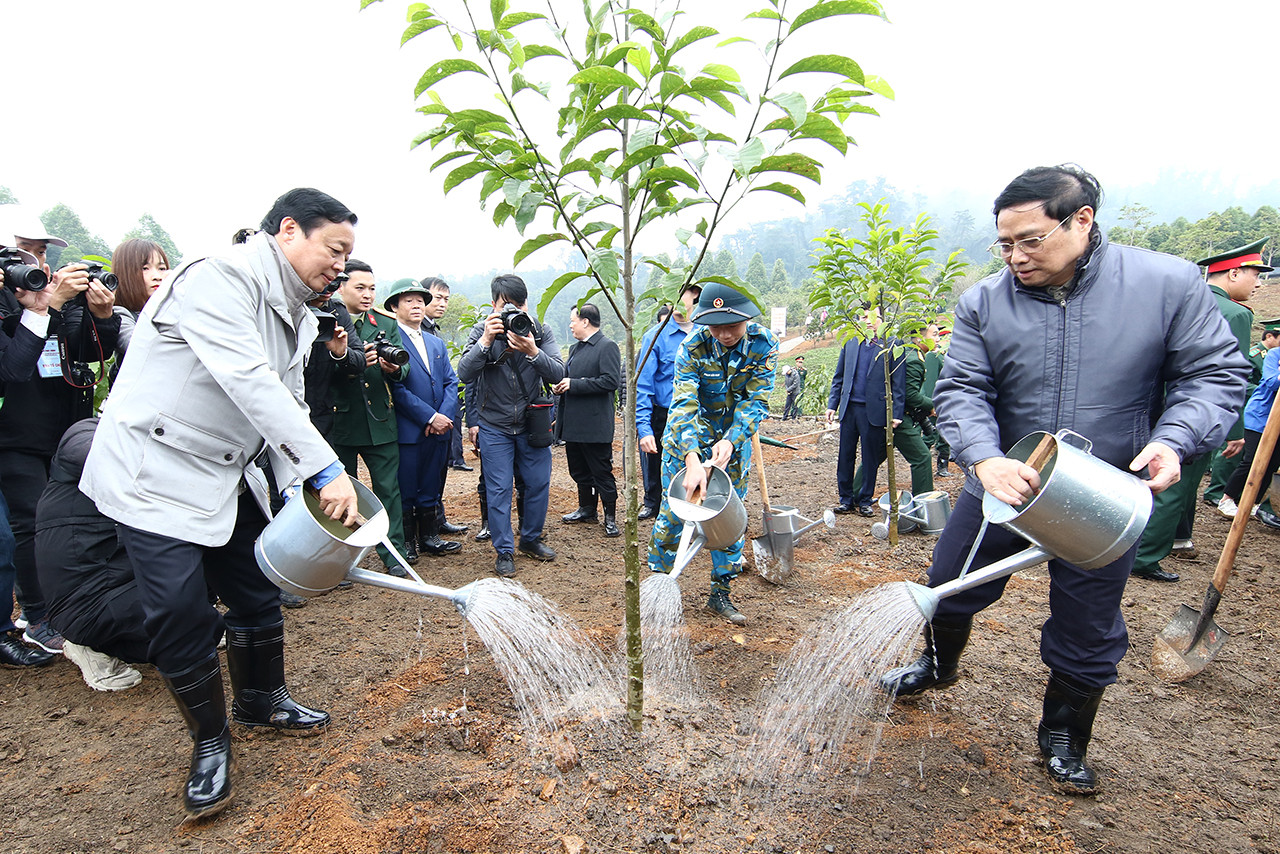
[253,475,475,613]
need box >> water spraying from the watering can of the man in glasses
[744,583,925,785]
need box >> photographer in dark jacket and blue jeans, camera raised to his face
[458,275,564,576]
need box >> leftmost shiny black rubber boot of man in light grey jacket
[164,656,233,818]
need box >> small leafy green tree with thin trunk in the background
[809,200,966,545]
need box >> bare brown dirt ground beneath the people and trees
[0,420,1280,854]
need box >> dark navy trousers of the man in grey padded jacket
[929,492,1137,688]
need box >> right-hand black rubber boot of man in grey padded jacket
[1038,672,1106,795]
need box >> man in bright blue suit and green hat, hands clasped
[383,279,462,557]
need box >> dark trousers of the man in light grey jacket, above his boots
[120,490,283,676]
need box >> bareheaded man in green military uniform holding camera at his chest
[328,259,417,577]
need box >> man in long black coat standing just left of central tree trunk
[552,302,622,536]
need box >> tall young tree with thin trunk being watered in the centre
[371,0,892,729]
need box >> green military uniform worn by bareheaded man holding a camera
[329,311,408,571]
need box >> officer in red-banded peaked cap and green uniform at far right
[1130,239,1271,581]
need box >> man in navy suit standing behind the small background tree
[827,315,906,516]
